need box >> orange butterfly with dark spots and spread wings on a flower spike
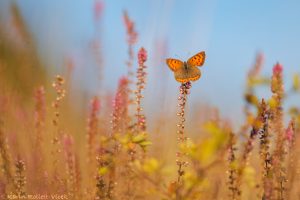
[166,51,205,83]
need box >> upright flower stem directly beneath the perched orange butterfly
[176,81,192,199]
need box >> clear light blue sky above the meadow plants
[0,0,300,123]
